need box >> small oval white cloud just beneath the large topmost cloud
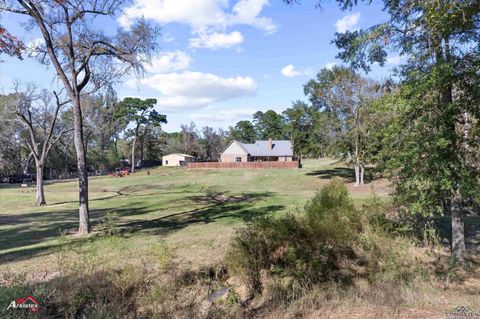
[145,50,192,73]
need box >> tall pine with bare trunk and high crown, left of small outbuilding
[117,97,167,173]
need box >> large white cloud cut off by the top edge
[118,0,277,48]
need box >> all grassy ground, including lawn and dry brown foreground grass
[0,159,479,318]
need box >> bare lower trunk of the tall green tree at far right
[450,190,465,264]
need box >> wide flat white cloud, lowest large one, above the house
[126,71,257,109]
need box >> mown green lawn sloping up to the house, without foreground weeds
[0,159,386,272]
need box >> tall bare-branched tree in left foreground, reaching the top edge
[0,0,157,234]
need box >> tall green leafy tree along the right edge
[286,0,480,263]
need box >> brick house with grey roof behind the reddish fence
[220,139,293,163]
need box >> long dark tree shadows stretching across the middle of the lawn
[0,188,278,262]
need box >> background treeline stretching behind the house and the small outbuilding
[0,68,385,179]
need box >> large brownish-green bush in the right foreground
[226,180,422,293]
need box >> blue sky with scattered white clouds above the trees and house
[0,0,401,132]
